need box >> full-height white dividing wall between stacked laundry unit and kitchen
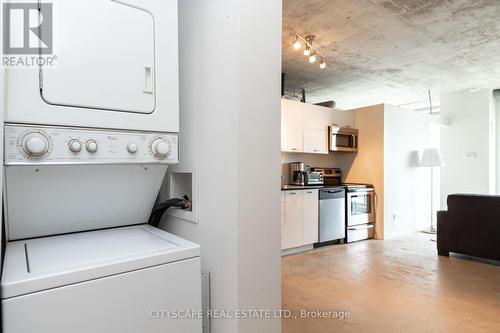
[162,0,281,333]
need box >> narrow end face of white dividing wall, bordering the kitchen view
[238,0,282,333]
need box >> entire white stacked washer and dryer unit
[1,0,201,333]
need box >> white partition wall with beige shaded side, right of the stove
[346,104,431,239]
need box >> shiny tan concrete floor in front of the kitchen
[282,234,500,333]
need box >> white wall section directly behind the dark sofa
[441,89,496,208]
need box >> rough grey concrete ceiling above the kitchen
[283,0,500,109]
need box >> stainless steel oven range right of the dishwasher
[346,184,375,243]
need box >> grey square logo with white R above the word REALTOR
[3,2,53,55]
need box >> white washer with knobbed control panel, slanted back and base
[1,124,201,333]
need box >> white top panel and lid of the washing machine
[1,225,199,299]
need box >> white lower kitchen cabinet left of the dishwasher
[281,190,319,250]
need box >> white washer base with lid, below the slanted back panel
[2,225,201,333]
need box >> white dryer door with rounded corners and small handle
[40,0,156,113]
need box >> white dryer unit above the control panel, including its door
[5,0,179,133]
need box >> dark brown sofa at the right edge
[437,194,500,260]
